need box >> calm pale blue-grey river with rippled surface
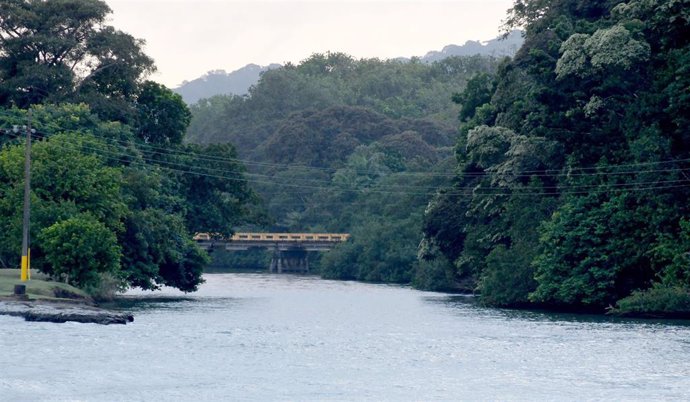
[0,274,690,401]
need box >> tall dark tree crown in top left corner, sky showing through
[0,0,154,121]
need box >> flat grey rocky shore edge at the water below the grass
[0,298,134,325]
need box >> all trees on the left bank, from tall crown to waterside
[0,0,256,295]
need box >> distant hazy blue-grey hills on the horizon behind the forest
[174,30,523,104]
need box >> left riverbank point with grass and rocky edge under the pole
[0,269,134,325]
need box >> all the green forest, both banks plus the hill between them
[0,0,690,314]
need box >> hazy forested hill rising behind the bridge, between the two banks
[187,53,499,283]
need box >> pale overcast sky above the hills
[105,0,512,88]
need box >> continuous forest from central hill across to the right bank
[188,0,690,313]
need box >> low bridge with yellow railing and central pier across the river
[194,233,350,273]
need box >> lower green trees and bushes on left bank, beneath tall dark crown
[0,104,255,296]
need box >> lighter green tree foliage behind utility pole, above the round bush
[0,134,126,270]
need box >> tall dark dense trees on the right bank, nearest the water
[421,0,690,312]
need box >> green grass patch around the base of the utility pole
[0,269,89,300]
